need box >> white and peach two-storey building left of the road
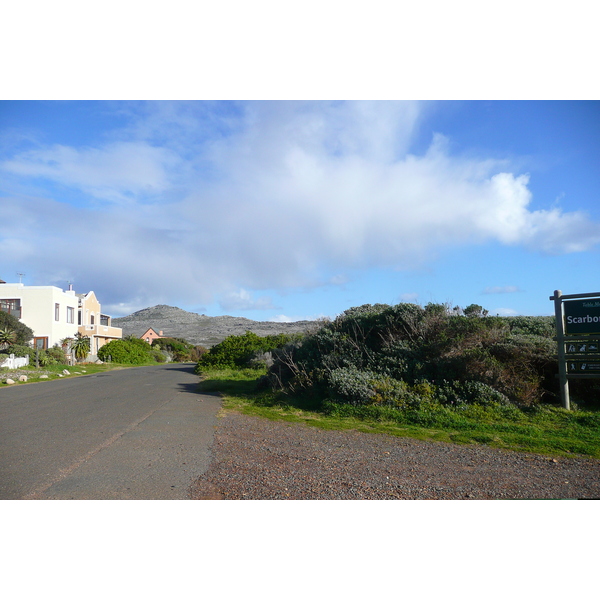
[0,280,122,355]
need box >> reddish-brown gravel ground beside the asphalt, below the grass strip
[190,412,600,500]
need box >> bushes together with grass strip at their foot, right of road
[196,303,600,458]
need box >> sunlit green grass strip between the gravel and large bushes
[200,369,600,459]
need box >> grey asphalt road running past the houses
[0,364,221,500]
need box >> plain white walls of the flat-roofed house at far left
[0,283,78,348]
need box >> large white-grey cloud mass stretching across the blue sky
[0,102,600,311]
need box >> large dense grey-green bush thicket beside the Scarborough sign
[268,303,576,408]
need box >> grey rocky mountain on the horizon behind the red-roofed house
[112,304,314,348]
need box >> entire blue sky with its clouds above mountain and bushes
[0,100,600,320]
